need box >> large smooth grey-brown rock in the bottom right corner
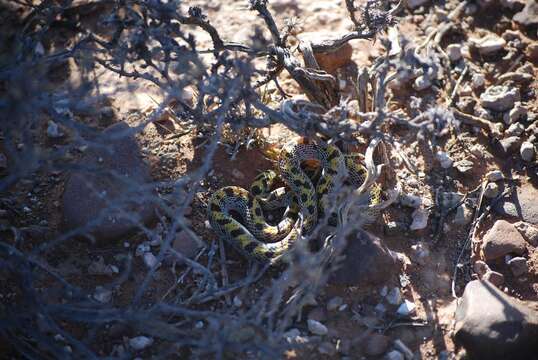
[454,280,538,360]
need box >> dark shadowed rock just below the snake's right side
[329,230,401,286]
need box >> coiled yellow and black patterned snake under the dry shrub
[207,139,382,263]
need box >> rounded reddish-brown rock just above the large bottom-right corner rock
[482,220,526,261]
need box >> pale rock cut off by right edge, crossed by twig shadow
[495,183,538,225]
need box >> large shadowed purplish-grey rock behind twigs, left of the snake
[63,123,155,241]
